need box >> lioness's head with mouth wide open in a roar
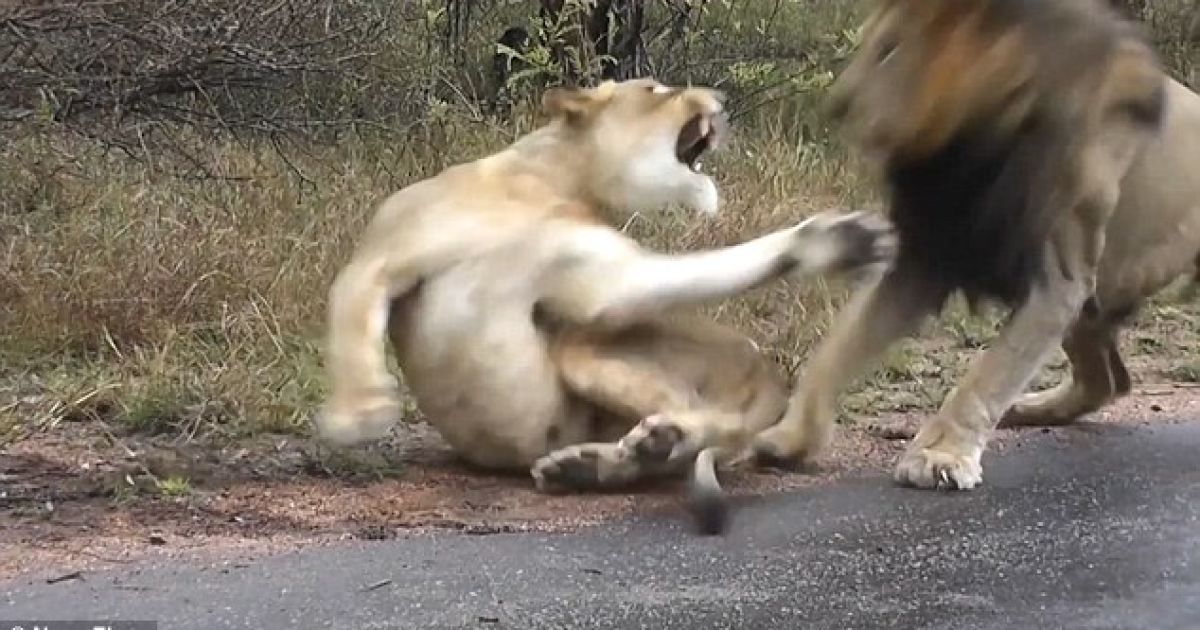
[542,78,727,215]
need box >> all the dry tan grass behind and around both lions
[0,2,1200,451]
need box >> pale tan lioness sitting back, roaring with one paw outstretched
[317,79,894,530]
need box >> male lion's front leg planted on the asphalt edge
[895,268,1090,490]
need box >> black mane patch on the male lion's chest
[888,117,1064,306]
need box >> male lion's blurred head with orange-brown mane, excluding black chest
[828,0,1152,161]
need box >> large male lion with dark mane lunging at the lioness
[754,0,1200,490]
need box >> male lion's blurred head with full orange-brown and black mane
[828,0,1162,304]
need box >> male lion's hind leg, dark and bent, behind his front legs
[998,316,1133,427]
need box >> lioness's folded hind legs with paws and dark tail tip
[533,323,787,534]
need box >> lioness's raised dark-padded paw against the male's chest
[792,211,899,274]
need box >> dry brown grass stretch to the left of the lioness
[0,130,380,439]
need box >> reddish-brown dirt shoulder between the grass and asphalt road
[0,384,1200,580]
